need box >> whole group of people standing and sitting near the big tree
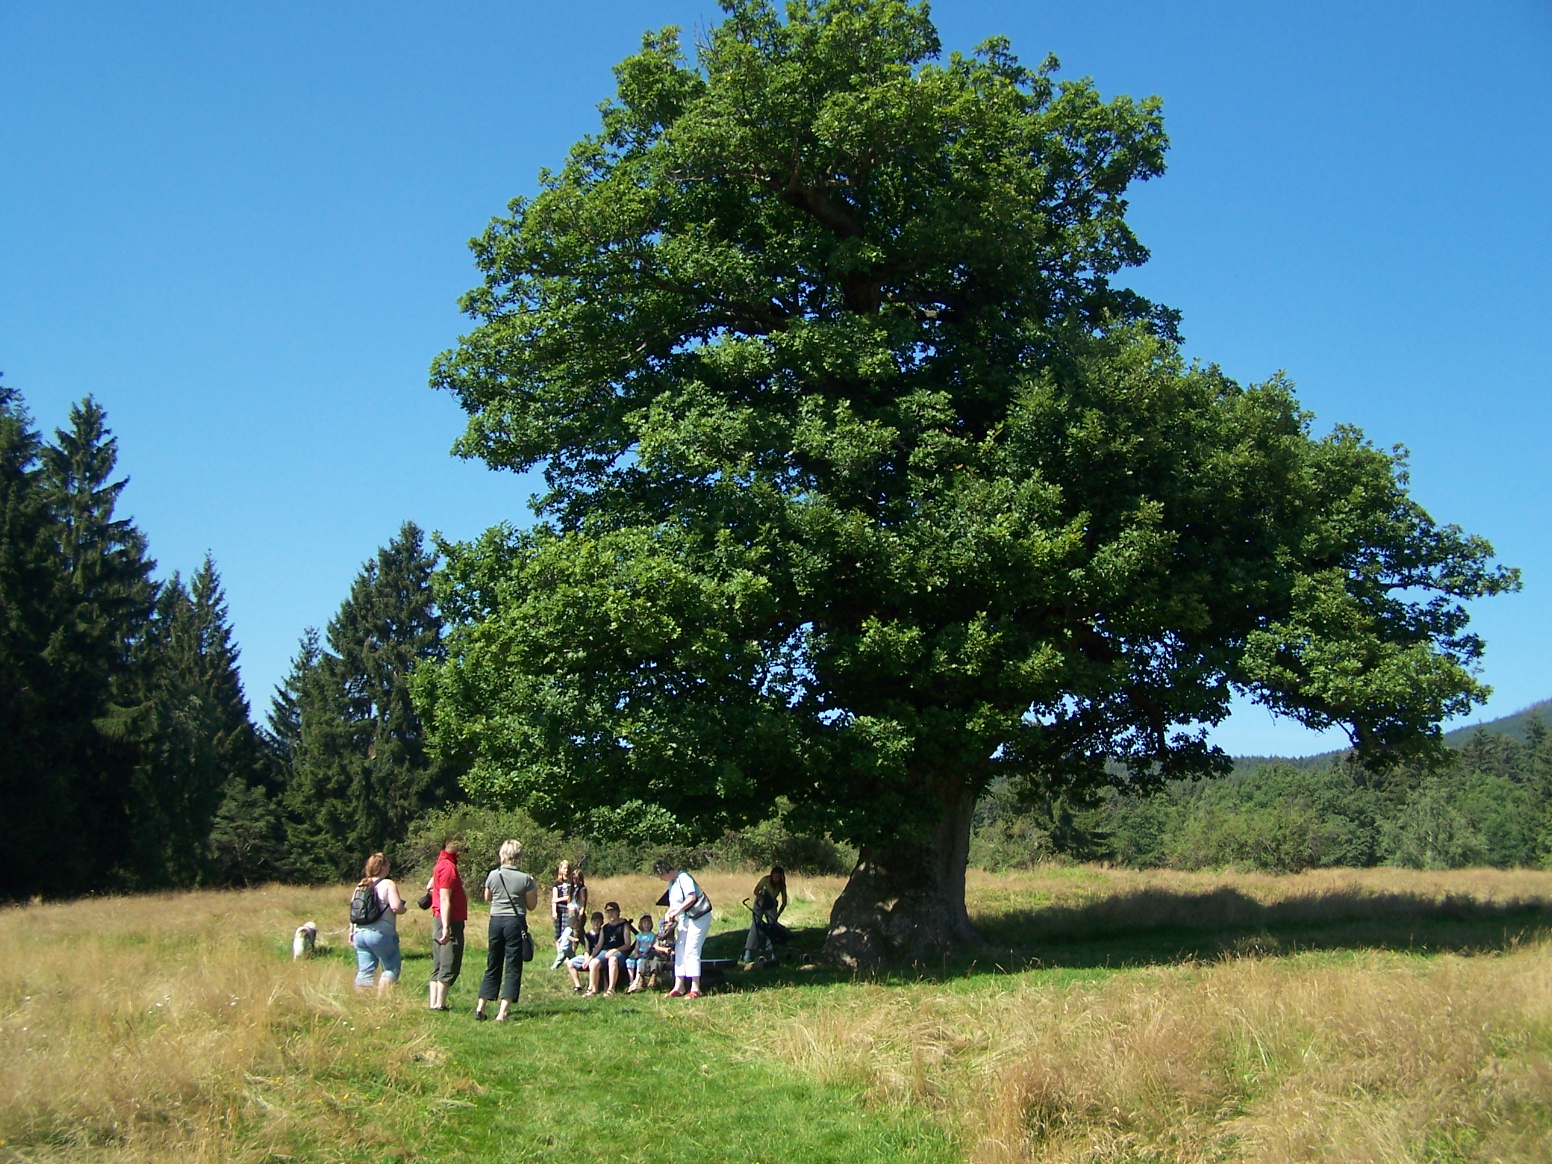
[351,838,787,1023]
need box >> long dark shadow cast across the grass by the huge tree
[708,888,1552,989]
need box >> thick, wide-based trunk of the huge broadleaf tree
[824,784,979,968]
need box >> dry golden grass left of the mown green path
[0,888,472,1161]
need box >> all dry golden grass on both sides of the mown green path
[0,868,1552,1164]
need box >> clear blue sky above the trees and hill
[0,0,1552,753]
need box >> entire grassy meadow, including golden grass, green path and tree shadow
[0,866,1552,1164]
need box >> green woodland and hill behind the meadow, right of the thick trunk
[970,700,1552,872]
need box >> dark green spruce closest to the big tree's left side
[282,521,456,877]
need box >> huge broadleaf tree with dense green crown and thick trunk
[417,0,1515,959]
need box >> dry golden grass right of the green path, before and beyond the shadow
[729,869,1552,1164]
